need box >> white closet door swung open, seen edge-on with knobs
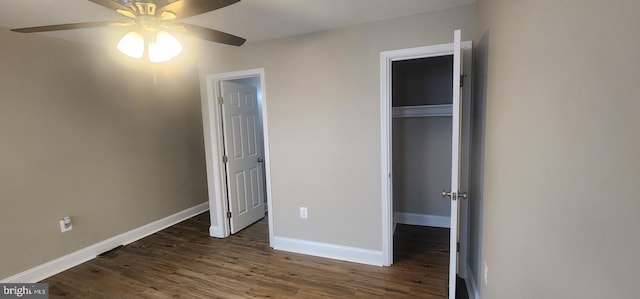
[449,30,466,299]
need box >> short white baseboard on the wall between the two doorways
[271,237,384,266]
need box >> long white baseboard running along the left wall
[0,202,209,283]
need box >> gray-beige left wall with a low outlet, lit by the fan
[0,28,207,279]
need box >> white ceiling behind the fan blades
[0,0,475,44]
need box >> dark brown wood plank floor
[43,213,458,298]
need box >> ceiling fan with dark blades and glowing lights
[11,0,246,62]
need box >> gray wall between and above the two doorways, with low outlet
[201,5,475,250]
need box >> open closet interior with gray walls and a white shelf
[391,54,453,227]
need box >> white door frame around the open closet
[380,41,472,268]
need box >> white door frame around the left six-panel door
[201,68,273,242]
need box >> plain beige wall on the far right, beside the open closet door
[476,0,640,299]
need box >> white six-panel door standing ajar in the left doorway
[220,81,265,234]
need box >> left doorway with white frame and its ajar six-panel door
[202,69,273,245]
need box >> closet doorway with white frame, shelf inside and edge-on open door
[380,31,471,298]
